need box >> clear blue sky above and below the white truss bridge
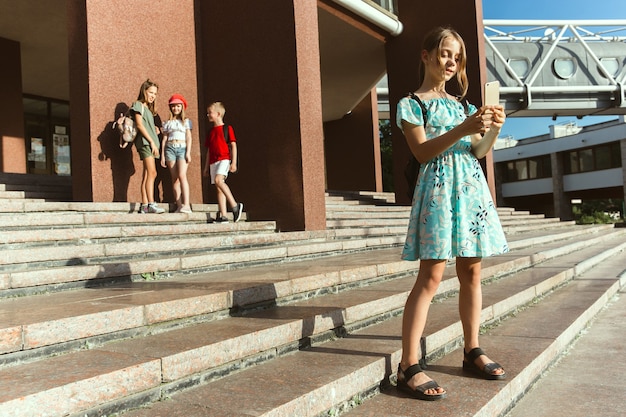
[482,0,626,139]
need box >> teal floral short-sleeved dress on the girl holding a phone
[396,97,509,261]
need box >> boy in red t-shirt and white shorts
[203,101,243,223]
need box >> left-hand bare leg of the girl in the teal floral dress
[400,260,446,395]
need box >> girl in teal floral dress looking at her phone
[397,28,508,401]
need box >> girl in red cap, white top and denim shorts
[161,94,191,213]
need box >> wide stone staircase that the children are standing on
[0,189,626,417]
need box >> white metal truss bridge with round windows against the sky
[484,20,626,118]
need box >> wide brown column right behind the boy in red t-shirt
[198,0,326,231]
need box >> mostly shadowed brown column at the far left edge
[0,38,26,174]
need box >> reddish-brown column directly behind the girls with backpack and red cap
[67,0,199,204]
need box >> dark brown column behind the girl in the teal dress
[387,0,496,204]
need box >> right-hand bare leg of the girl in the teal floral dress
[456,258,504,375]
